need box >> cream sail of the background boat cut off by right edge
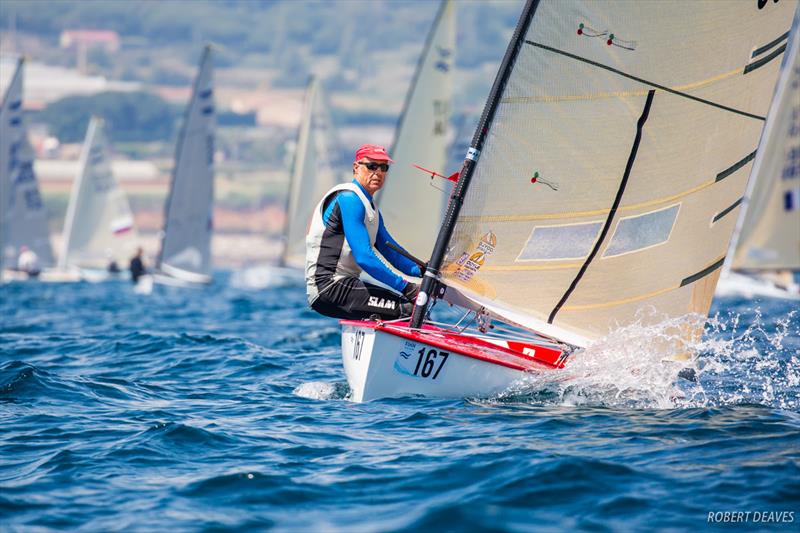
[730,11,800,271]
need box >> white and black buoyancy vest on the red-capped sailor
[306,182,380,303]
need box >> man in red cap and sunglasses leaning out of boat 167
[306,144,422,320]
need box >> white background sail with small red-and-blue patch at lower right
[58,117,138,270]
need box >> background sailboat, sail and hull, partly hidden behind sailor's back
[234,76,342,288]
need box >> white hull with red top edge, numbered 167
[342,321,560,402]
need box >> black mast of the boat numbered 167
[411,0,539,328]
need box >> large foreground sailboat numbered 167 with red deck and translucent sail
[341,0,796,401]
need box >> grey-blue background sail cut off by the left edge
[0,59,53,268]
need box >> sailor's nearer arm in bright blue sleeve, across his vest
[337,192,408,292]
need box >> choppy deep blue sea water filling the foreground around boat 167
[0,273,800,532]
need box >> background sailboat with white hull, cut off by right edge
[716,12,800,299]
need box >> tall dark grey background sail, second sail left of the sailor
[157,46,216,283]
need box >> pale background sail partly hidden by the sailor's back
[281,78,342,268]
